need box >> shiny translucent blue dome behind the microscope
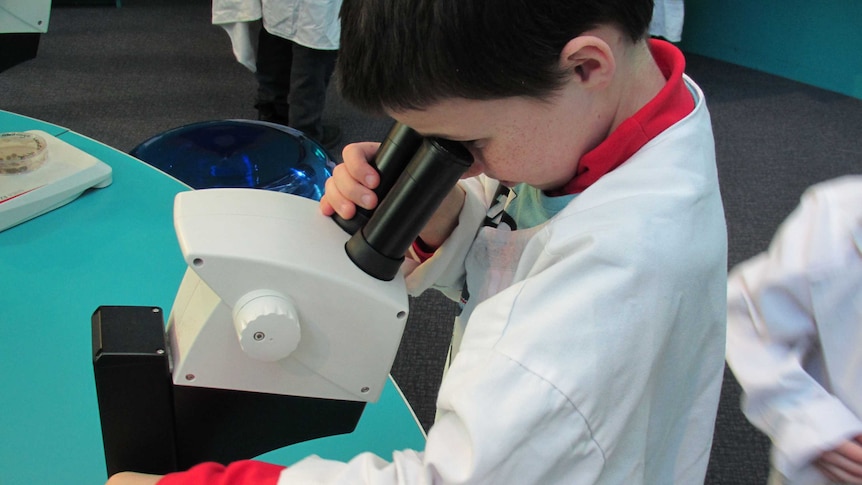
[129,120,335,200]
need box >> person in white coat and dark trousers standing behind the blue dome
[212,0,341,148]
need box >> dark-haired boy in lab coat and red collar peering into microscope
[108,0,727,484]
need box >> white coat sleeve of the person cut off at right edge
[727,182,862,477]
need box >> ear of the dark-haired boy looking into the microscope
[560,35,616,86]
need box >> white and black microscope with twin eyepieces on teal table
[92,123,472,476]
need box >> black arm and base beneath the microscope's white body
[92,306,365,476]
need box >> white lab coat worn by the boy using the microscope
[279,73,727,485]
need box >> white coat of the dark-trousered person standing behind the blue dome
[212,0,342,71]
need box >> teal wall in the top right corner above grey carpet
[679,0,862,99]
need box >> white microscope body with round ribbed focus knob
[168,189,408,402]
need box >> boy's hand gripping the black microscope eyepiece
[320,142,380,219]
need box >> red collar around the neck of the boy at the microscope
[548,39,694,196]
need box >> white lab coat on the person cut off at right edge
[727,176,862,485]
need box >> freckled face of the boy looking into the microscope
[389,89,607,190]
